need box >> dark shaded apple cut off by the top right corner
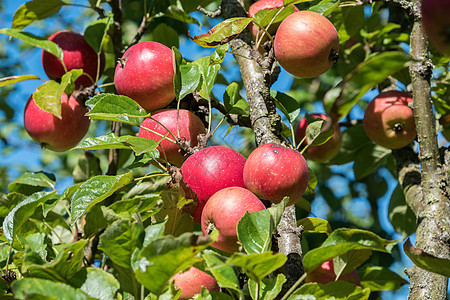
[421,0,450,55]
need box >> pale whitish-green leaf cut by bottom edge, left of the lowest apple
[71,267,120,300]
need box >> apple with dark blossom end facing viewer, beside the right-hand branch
[363,91,417,149]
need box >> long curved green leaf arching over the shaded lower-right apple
[303,228,397,273]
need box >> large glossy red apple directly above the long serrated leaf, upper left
[114,42,175,111]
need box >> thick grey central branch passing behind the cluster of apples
[221,0,304,291]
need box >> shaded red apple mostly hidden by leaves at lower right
[305,259,361,286]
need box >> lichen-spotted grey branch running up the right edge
[408,0,450,299]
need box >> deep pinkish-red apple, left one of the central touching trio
[180,146,245,224]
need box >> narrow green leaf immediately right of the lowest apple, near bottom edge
[202,250,242,294]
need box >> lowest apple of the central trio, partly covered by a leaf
[201,187,266,252]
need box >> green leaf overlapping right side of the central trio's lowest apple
[237,201,286,253]
